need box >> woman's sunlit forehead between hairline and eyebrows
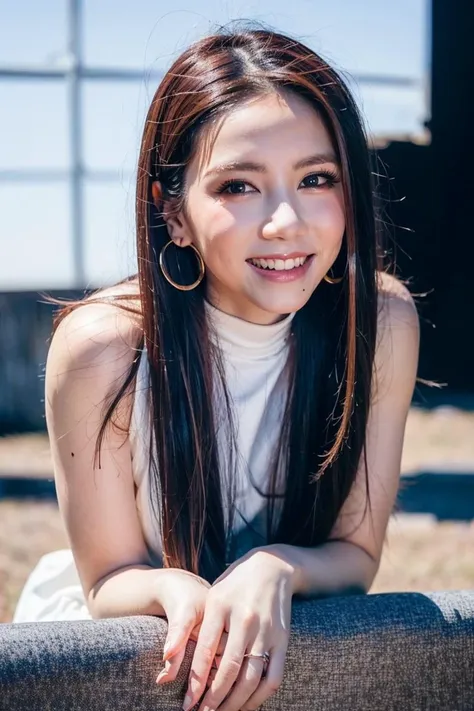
[189,92,333,180]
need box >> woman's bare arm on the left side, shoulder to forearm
[46,304,166,617]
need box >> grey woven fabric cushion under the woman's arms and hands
[0,591,474,711]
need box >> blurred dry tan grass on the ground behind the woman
[0,407,474,622]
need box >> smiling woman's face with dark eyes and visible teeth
[156,92,345,324]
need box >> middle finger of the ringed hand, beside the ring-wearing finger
[195,624,249,711]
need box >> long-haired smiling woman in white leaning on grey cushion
[14,29,418,711]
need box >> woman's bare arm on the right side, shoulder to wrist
[267,277,419,596]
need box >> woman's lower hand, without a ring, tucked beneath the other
[156,568,225,684]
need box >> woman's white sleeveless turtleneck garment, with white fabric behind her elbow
[13,301,294,622]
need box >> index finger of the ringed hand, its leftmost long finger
[183,607,225,708]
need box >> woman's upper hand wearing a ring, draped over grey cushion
[183,546,295,711]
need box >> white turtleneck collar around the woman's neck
[204,299,295,359]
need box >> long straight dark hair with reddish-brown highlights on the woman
[46,26,381,580]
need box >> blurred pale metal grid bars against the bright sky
[0,0,420,289]
